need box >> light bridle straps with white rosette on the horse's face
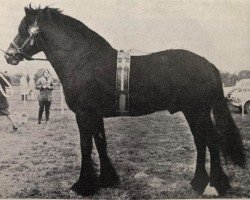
[11,20,40,53]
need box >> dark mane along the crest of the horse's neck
[26,5,111,48]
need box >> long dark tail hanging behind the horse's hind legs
[212,73,246,168]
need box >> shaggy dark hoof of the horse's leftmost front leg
[71,180,99,196]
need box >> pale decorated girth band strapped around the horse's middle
[116,50,131,115]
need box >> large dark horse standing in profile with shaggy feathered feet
[5,7,246,195]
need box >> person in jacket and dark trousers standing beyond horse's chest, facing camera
[36,69,54,124]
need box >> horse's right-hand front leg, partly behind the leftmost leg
[94,117,119,187]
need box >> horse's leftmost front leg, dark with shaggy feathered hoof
[72,112,99,196]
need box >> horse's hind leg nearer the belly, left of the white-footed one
[183,109,209,194]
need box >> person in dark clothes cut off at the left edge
[0,72,17,131]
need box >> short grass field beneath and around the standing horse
[0,87,250,199]
